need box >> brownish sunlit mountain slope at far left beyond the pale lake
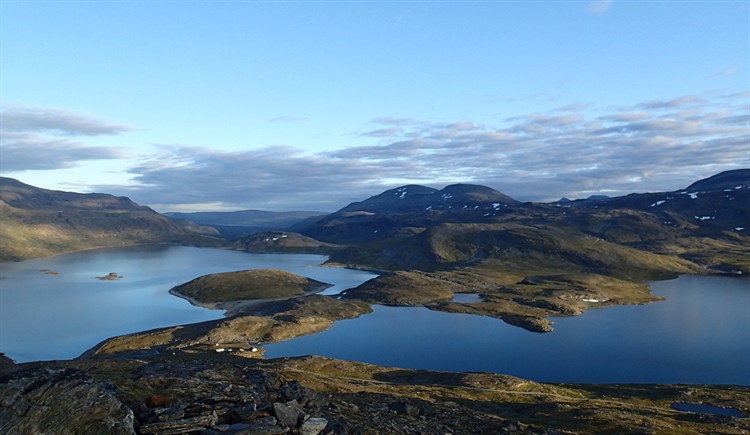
[0,178,219,261]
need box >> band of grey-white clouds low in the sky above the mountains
[2,93,750,211]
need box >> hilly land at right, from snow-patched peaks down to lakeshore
[290,170,750,332]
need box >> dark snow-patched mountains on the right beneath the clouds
[282,169,750,252]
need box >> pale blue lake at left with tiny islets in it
[0,245,376,362]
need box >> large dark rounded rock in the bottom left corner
[0,368,135,435]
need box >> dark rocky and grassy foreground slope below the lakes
[0,354,750,435]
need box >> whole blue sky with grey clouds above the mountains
[0,0,750,212]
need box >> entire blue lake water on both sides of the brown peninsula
[0,245,750,385]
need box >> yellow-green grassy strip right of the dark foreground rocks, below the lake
[274,357,750,434]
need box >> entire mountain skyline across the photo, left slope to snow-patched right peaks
[0,169,750,268]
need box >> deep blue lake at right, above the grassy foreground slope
[266,276,750,385]
